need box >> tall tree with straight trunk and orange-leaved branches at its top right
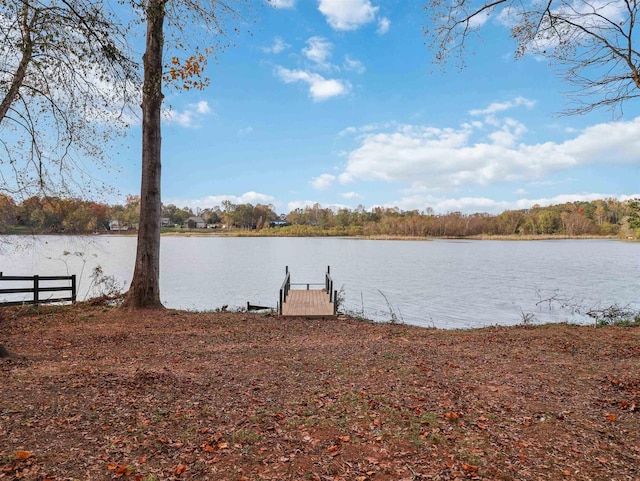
[123,0,258,309]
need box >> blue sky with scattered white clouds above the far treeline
[108,0,640,213]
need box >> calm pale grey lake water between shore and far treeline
[0,236,640,328]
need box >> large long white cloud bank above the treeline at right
[338,102,640,190]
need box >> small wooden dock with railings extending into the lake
[278,267,337,318]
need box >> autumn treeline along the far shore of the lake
[0,194,640,239]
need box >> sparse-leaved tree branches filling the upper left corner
[0,0,138,197]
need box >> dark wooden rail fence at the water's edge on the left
[0,272,77,306]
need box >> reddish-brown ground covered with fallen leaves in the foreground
[0,306,640,481]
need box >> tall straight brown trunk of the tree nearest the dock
[123,0,166,309]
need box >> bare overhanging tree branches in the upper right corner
[425,0,640,114]
